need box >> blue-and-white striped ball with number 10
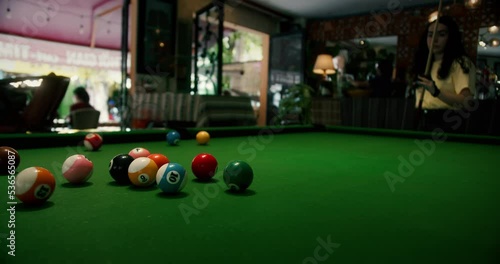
[156,163,187,194]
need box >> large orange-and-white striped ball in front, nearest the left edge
[15,167,56,205]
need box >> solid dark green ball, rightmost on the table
[223,160,253,192]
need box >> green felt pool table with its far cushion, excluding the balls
[0,126,500,264]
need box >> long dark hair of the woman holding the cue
[412,16,469,79]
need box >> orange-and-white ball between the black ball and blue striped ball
[128,157,158,187]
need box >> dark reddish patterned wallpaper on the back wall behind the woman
[306,0,500,81]
